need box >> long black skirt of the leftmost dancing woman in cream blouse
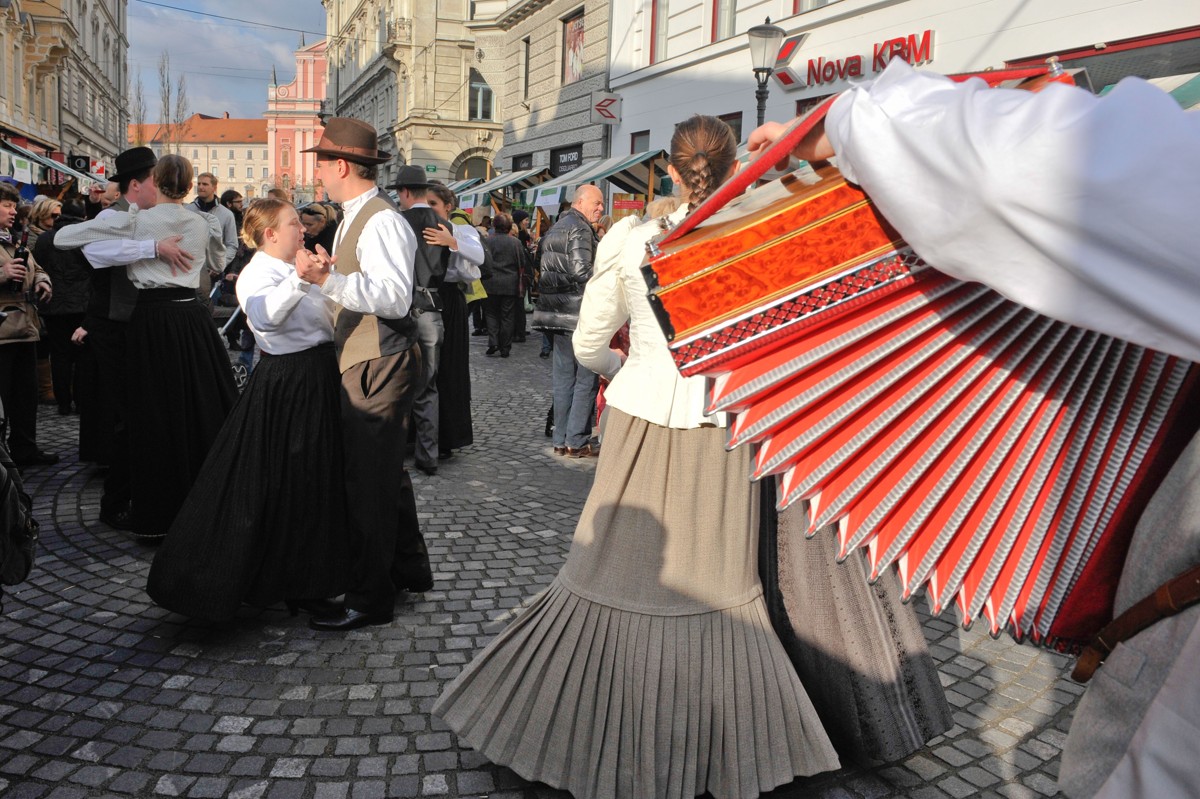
[126,288,238,539]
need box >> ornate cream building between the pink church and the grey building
[323,0,503,185]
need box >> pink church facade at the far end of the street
[262,36,328,203]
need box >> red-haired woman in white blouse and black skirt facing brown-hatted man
[146,199,354,621]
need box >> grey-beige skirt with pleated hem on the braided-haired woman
[433,408,839,799]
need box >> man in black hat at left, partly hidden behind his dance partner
[71,148,192,530]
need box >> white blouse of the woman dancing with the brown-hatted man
[238,251,334,355]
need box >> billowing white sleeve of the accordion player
[826,60,1200,360]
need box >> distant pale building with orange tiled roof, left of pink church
[128,112,275,198]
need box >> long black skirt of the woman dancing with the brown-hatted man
[146,344,354,621]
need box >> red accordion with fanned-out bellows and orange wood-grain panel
[643,170,1198,648]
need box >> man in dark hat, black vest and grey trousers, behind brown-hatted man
[391,166,451,476]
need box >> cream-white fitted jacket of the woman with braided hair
[571,206,726,429]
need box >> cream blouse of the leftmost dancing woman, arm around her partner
[54,203,224,289]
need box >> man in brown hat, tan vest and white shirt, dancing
[296,118,433,631]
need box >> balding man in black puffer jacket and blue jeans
[533,184,604,457]
